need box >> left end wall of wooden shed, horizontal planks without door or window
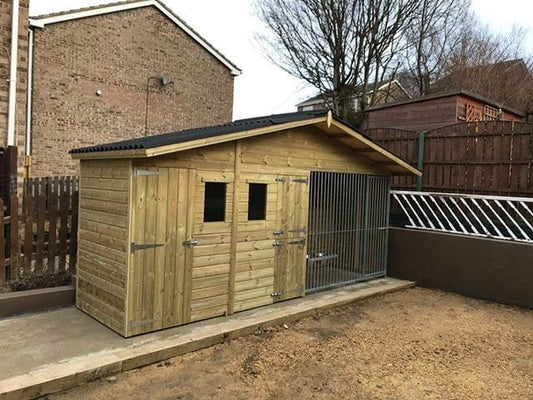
[76,160,131,335]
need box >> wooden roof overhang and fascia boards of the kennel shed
[71,111,422,176]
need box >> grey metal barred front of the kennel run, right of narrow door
[306,172,390,293]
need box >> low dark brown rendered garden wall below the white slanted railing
[387,228,533,309]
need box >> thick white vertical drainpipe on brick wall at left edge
[7,0,19,146]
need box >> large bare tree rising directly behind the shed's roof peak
[256,0,418,120]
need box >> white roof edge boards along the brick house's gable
[29,0,242,76]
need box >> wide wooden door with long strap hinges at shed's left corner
[126,167,195,336]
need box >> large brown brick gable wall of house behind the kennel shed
[32,7,233,176]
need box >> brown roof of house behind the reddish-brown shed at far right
[432,59,533,112]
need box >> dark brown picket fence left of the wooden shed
[0,176,79,284]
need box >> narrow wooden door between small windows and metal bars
[274,175,309,301]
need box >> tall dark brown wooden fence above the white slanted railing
[366,121,533,197]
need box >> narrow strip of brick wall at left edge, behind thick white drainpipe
[0,0,29,180]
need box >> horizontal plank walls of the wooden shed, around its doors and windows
[78,126,390,336]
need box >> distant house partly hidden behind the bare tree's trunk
[296,79,411,112]
